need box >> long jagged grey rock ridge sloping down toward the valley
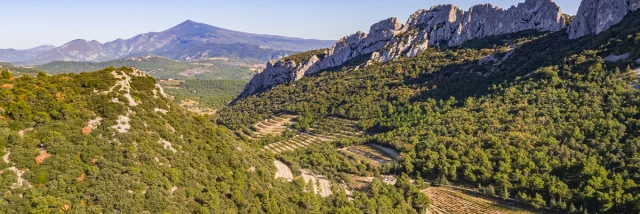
[238,0,565,98]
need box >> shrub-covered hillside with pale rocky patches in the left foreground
[0,67,428,213]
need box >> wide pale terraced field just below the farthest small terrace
[263,118,364,154]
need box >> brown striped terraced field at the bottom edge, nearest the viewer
[422,187,534,214]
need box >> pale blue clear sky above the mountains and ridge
[0,0,580,49]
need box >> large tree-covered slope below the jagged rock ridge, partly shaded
[218,12,640,213]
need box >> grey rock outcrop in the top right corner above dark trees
[567,0,640,39]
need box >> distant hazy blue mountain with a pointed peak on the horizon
[0,20,334,65]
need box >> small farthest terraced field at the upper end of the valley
[237,114,298,140]
